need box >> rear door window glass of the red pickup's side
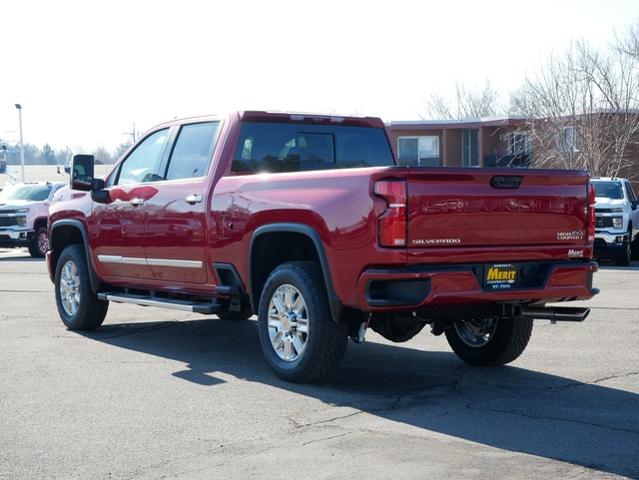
[166,122,219,180]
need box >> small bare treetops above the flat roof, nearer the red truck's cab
[421,80,505,120]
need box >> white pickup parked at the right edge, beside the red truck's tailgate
[591,177,639,266]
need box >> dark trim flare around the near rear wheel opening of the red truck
[247,223,342,322]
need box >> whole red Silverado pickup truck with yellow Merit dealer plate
[47,112,597,382]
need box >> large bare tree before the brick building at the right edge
[511,30,639,176]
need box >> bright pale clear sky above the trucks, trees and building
[0,0,639,150]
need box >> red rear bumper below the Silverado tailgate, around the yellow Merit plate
[357,261,598,312]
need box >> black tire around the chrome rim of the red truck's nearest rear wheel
[258,262,348,383]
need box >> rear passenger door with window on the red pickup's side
[145,122,220,287]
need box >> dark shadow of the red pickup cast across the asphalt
[85,320,639,478]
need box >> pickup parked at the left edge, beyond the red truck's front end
[0,182,65,257]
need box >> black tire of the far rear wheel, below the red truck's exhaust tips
[446,318,533,366]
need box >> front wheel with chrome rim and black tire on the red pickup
[55,245,109,330]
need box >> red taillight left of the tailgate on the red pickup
[373,180,406,247]
